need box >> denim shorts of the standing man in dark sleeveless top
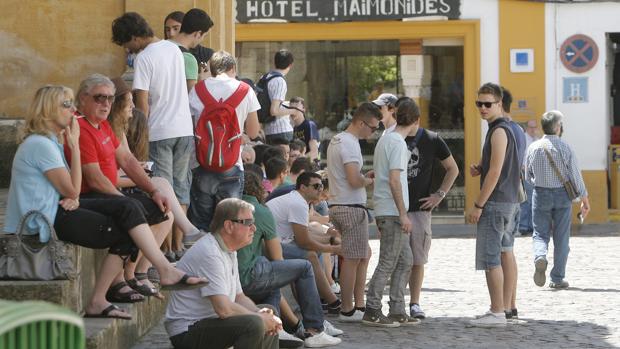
[476,201,519,270]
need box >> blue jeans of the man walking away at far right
[532,187,573,283]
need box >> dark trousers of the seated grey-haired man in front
[170,315,279,349]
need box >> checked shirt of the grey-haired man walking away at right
[525,135,588,197]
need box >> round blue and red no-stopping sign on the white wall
[560,34,598,73]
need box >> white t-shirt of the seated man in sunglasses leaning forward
[265,190,310,244]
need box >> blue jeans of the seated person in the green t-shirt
[243,256,323,331]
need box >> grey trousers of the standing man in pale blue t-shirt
[366,216,413,314]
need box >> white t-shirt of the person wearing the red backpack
[189,74,260,168]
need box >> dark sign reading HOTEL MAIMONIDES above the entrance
[237,0,461,23]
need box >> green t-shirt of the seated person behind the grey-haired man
[237,195,278,285]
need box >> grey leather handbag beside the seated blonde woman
[0,210,77,281]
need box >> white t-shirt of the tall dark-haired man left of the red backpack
[133,40,194,142]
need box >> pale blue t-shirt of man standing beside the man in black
[372,132,411,217]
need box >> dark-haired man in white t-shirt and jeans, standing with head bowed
[112,12,194,220]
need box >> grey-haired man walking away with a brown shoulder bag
[526,110,590,289]
